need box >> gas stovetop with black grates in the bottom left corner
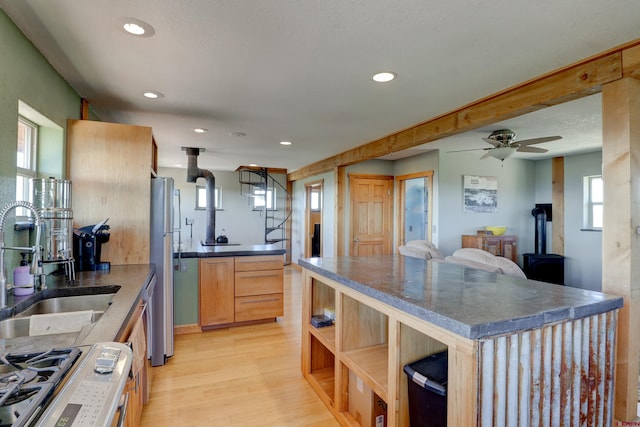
[0,348,80,427]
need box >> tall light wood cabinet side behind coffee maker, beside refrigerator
[67,120,156,265]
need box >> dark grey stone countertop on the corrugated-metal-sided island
[298,255,623,339]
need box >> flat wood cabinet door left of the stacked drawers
[198,257,235,327]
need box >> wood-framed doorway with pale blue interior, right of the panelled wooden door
[396,171,433,246]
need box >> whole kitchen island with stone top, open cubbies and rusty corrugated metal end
[299,255,622,427]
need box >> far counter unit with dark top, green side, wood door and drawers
[174,242,285,333]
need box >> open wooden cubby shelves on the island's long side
[302,270,447,427]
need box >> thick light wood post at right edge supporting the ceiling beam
[602,78,640,421]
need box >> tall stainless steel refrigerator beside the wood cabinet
[148,177,179,366]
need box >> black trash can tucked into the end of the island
[404,351,448,427]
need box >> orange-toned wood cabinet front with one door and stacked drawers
[199,255,284,329]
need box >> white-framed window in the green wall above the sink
[16,117,38,217]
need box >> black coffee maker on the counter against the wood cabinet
[73,218,111,271]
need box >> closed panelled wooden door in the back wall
[349,175,393,256]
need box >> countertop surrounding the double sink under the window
[0,264,155,353]
